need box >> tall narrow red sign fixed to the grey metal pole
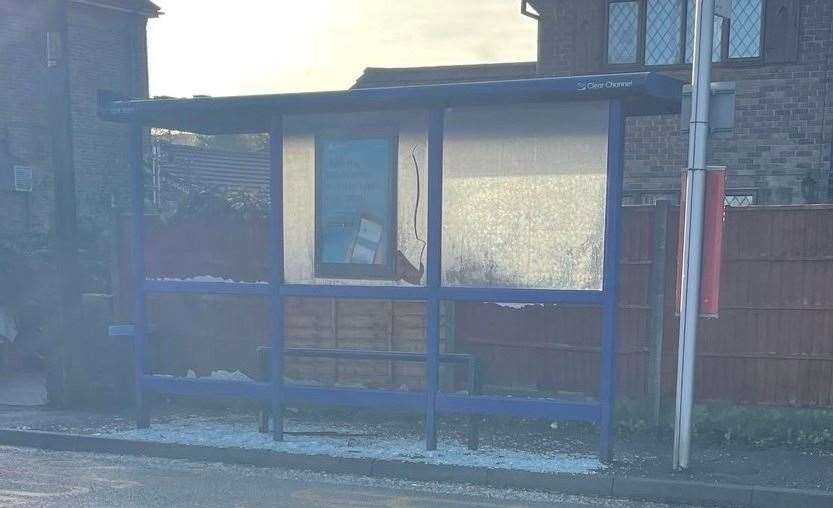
[674,166,726,318]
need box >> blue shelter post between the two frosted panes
[425,109,445,450]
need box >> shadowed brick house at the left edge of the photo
[0,0,160,235]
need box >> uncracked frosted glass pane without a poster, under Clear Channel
[442,102,609,289]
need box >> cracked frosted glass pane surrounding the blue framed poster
[284,111,428,285]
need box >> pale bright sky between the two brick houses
[148,0,537,97]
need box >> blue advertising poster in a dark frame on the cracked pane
[315,130,398,279]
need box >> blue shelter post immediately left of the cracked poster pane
[269,116,284,441]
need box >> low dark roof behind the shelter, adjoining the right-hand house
[352,62,537,88]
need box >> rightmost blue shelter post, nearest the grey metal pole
[599,100,625,462]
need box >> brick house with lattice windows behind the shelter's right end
[355,0,833,206]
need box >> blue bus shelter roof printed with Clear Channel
[99,72,682,134]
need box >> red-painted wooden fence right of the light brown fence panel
[456,206,833,406]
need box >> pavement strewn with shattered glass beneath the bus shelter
[0,407,833,508]
